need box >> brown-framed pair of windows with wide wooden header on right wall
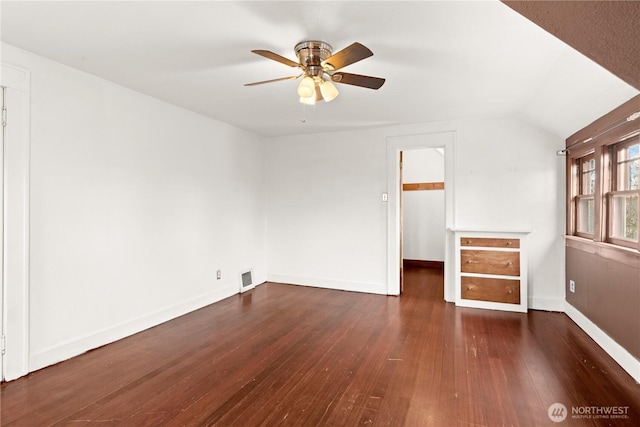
[563,95,640,254]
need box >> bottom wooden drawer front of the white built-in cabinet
[461,276,520,304]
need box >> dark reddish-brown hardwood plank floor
[0,268,640,427]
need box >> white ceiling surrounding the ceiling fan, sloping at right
[0,0,638,138]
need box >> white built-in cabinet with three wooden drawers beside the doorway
[456,231,527,312]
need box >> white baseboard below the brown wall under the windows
[564,302,640,383]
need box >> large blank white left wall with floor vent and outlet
[2,44,266,370]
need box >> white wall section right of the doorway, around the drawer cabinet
[455,119,566,311]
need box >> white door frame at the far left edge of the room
[0,63,30,380]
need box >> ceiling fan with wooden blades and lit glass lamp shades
[245,40,385,105]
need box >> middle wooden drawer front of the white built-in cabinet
[460,250,520,276]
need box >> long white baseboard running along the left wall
[29,287,239,372]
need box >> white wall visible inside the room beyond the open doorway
[402,148,446,261]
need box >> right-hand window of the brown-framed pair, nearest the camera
[608,137,640,248]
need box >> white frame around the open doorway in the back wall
[387,131,455,302]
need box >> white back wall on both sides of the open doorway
[267,117,564,310]
